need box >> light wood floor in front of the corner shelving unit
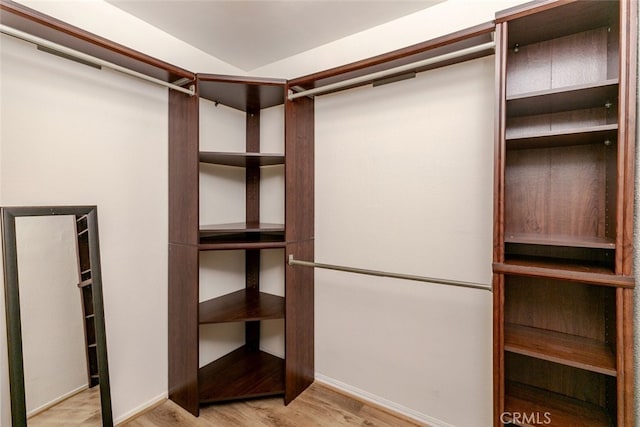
[119,383,423,427]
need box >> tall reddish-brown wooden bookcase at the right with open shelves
[493,0,637,426]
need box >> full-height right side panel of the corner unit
[285,92,315,404]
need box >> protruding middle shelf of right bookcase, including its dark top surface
[493,257,635,288]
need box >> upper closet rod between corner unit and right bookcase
[288,41,496,101]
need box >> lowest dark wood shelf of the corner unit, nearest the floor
[198,346,284,403]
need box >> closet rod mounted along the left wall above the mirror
[0,25,195,96]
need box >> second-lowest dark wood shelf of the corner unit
[198,289,284,324]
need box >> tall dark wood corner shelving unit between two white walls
[169,74,314,415]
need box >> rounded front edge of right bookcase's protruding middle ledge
[493,262,635,288]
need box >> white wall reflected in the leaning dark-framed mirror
[16,215,88,415]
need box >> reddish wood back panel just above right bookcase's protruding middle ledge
[505,144,616,242]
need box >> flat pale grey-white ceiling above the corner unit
[107,0,444,71]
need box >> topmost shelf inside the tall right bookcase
[507,79,618,117]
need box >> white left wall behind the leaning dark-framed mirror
[0,36,167,424]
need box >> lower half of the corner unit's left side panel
[169,244,199,416]
